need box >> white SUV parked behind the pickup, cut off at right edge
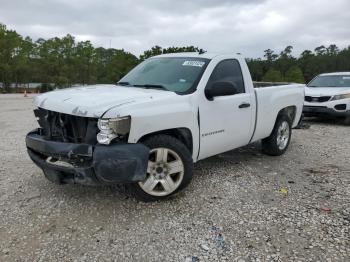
[303,72,350,125]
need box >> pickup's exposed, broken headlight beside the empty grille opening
[97,116,131,145]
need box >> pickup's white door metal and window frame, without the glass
[196,55,256,160]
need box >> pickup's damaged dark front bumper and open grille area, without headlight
[26,109,149,185]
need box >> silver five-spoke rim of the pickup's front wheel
[139,147,184,196]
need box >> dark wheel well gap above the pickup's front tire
[138,128,193,154]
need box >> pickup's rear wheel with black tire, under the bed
[262,115,292,156]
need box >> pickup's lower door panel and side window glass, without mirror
[198,59,255,159]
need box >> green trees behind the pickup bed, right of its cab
[247,44,350,83]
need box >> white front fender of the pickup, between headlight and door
[103,91,199,160]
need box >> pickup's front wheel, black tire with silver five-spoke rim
[126,135,193,202]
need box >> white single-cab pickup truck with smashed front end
[26,53,304,201]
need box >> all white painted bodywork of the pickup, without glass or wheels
[35,53,304,162]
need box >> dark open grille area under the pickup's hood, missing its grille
[34,108,98,144]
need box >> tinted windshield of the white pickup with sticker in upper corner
[118,57,209,93]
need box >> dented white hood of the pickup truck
[35,85,176,118]
